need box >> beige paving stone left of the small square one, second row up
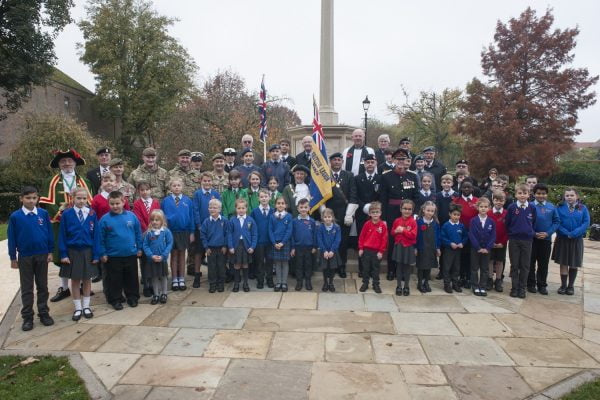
[267,332,325,361]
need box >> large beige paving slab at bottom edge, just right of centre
[309,362,410,400]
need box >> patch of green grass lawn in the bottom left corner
[0,356,90,400]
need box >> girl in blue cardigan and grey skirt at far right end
[552,188,590,296]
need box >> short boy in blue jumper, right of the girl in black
[441,203,469,293]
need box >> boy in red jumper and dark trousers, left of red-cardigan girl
[358,201,388,293]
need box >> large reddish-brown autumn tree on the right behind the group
[459,8,598,176]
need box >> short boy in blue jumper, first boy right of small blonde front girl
[200,199,229,293]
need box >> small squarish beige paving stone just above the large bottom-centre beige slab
[325,334,373,363]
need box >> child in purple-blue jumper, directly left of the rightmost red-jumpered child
[469,197,496,296]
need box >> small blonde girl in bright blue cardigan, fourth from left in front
[142,210,173,305]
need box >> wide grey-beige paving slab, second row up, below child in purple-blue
[419,336,513,365]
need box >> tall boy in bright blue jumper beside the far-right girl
[527,184,560,295]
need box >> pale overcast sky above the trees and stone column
[56,0,600,141]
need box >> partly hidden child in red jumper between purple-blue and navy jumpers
[487,190,508,292]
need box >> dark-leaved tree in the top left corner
[0,0,73,120]
